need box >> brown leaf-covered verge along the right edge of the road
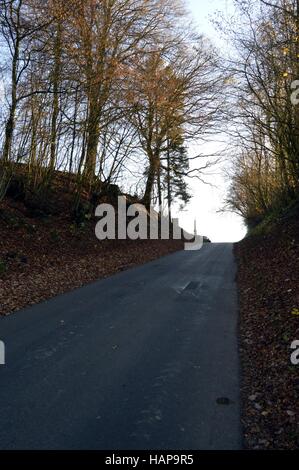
[236,211,299,449]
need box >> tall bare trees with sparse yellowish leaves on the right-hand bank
[223,0,299,224]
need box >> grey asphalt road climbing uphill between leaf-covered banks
[0,244,242,450]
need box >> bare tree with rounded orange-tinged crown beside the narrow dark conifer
[126,38,223,207]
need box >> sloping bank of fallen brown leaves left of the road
[0,198,183,315]
